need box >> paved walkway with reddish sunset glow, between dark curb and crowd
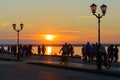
[27,57,120,71]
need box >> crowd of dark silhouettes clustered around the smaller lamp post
[0,45,33,57]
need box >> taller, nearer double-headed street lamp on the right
[90,3,107,69]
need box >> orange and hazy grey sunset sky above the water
[0,0,120,44]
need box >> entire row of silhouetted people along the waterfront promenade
[0,42,119,62]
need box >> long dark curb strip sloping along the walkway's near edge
[27,62,120,77]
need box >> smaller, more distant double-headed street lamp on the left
[12,23,24,61]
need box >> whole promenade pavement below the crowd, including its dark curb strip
[0,55,120,77]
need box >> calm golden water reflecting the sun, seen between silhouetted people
[33,46,120,61]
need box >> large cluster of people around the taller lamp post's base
[82,42,119,62]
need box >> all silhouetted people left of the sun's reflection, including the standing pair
[0,45,46,57]
